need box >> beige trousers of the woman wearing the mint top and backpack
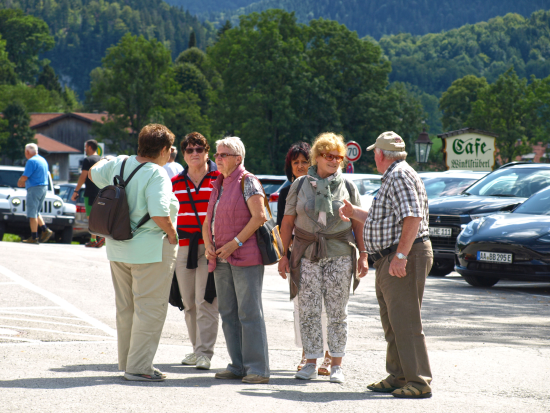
[111,238,178,374]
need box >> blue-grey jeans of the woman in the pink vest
[214,262,269,377]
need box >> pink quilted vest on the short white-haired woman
[206,165,263,271]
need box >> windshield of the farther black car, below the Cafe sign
[463,168,550,198]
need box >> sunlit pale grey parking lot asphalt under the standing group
[0,243,550,413]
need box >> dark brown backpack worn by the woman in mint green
[88,158,151,241]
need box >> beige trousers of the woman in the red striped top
[176,244,220,359]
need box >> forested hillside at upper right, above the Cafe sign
[379,11,550,96]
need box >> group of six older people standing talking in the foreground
[88,124,433,398]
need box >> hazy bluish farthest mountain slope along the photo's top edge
[205,0,550,39]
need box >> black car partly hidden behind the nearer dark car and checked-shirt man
[429,162,550,276]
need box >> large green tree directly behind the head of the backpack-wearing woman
[87,33,208,153]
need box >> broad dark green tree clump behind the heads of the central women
[208,10,423,172]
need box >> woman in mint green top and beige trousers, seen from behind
[89,124,179,382]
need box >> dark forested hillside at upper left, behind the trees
[0,0,215,97]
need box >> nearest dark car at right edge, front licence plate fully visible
[456,187,550,287]
